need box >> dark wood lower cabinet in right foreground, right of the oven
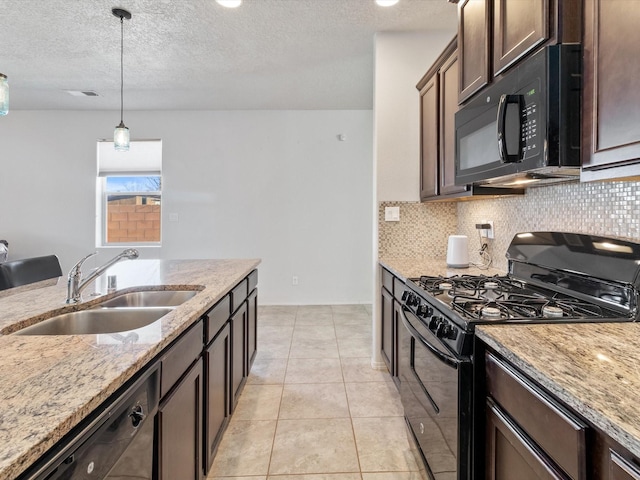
[474,342,640,480]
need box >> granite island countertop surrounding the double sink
[0,259,260,480]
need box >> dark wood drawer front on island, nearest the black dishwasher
[160,320,204,398]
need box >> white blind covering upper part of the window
[97,140,162,177]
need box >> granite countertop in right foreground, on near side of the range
[476,323,640,458]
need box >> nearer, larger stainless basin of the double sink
[14,307,173,335]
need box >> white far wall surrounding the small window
[0,111,373,304]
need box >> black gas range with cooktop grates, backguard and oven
[398,232,640,480]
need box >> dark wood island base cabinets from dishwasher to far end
[153,271,258,480]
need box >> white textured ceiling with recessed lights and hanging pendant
[0,0,457,110]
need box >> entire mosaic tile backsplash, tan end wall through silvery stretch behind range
[378,182,640,270]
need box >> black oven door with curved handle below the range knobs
[398,307,472,480]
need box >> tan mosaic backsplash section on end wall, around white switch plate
[378,202,458,260]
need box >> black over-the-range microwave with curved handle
[455,44,582,187]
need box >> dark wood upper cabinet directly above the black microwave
[458,0,582,103]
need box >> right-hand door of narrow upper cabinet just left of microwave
[439,52,467,195]
